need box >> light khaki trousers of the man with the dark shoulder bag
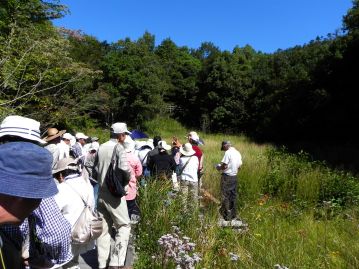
[97,190,131,268]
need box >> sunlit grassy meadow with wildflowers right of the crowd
[89,119,359,269]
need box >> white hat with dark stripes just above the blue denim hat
[0,116,46,144]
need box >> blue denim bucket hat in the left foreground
[0,142,58,199]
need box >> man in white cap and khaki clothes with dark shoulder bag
[96,122,131,269]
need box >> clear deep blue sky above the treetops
[54,0,352,52]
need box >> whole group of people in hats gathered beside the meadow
[0,116,242,269]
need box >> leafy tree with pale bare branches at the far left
[0,0,94,125]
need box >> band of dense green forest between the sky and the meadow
[0,0,359,168]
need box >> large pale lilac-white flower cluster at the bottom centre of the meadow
[158,226,201,269]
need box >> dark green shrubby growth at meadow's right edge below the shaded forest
[262,148,359,206]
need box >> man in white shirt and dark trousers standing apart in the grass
[216,141,242,221]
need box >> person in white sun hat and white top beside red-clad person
[178,143,198,205]
